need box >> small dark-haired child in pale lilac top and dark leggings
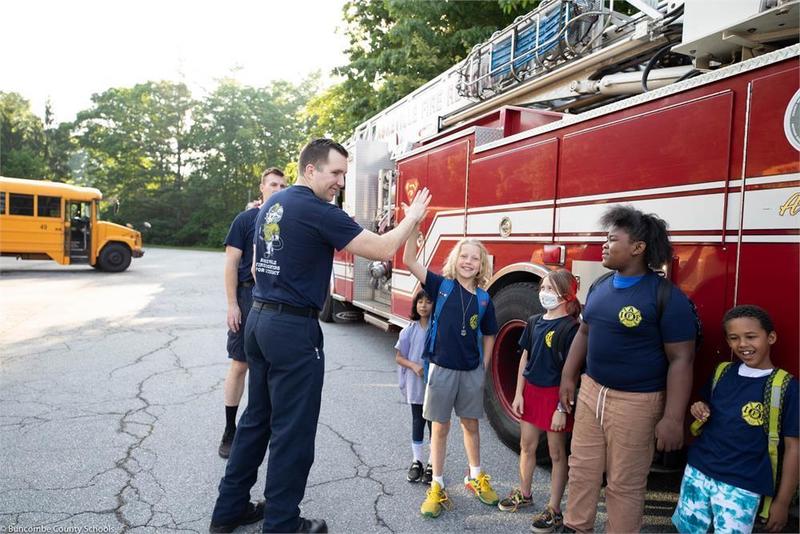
[394,291,433,484]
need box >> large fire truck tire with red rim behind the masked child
[483,282,550,464]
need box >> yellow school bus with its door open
[0,176,144,273]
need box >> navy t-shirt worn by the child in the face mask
[519,315,578,388]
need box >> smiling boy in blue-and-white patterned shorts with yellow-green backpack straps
[672,306,800,533]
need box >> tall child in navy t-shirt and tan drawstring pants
[559,206,697,532]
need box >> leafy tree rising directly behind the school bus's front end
[75,82,194,240]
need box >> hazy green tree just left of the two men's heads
[184,75,318,245]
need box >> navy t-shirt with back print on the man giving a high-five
[253,185,363,310]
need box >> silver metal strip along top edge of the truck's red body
[474,44,800,154]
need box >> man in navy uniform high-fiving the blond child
[210,139,430,532]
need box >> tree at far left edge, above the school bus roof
[0,92,48,179]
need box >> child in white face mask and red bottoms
[498,269,581,532]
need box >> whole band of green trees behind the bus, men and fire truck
[6,0,564,247]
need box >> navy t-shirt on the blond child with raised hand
[423,271,497,371]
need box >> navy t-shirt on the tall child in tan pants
[583,271,696,393]
